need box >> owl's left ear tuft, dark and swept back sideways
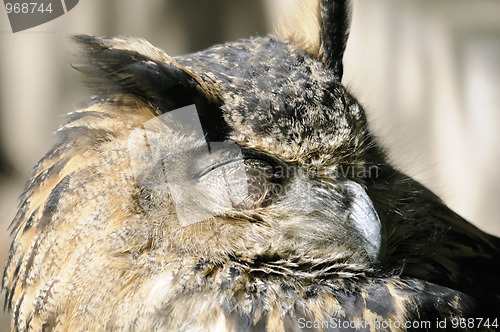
[72,35,218,113]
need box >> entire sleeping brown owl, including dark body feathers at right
[2,0,500,331]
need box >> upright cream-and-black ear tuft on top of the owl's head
[278,0,350,81]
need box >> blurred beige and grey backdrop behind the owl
[0,0,500,331]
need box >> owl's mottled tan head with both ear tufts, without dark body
[3,0,398,329]
